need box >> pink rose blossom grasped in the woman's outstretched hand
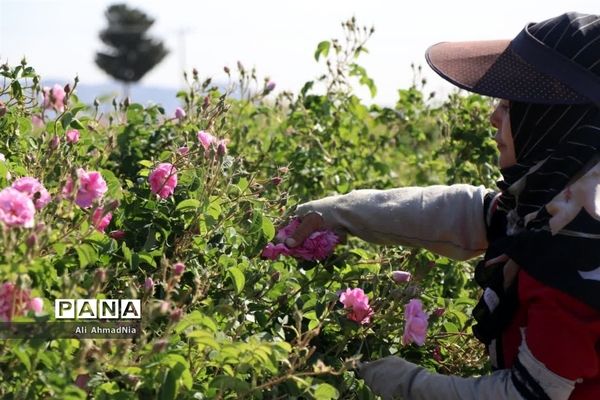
[262,218,339,260]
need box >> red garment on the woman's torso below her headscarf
[502,269,600,400]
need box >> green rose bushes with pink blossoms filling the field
[0,20,498,399]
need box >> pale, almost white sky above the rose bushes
[0,0,600,103]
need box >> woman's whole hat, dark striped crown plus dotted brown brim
[425,12,600,107]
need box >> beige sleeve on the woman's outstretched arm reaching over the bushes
[296,184,488,260]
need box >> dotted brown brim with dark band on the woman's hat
[425,40,590,104]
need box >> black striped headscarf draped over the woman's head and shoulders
[473,14,600,368]
